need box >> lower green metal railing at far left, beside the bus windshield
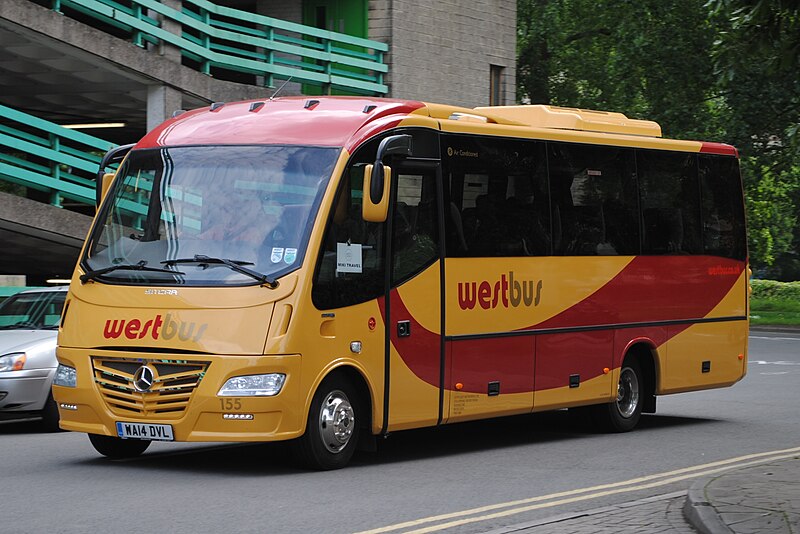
[0,105,115,207]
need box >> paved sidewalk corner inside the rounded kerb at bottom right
[684,455,800,534]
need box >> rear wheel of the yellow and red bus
[594,359,644,432]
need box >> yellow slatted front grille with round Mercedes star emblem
[92,358,208,419]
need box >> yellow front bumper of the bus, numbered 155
[53,347,305,441]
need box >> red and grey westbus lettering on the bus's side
[458,271,542,310]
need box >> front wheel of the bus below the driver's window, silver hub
[294,376,362,471]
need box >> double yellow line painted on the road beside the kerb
[357,447,800,534]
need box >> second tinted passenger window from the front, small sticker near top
[548,143,639,256]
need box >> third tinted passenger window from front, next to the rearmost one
[636,150,702,254]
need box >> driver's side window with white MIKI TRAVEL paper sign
[311,165,385,310]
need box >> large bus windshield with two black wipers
[82,145,339,286]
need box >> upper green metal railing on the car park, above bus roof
[52,0,388,95]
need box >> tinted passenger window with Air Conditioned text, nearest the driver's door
[442,136,550,256]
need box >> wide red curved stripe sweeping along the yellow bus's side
[379,256,745,393]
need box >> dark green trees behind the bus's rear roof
[517,0,800,277]
